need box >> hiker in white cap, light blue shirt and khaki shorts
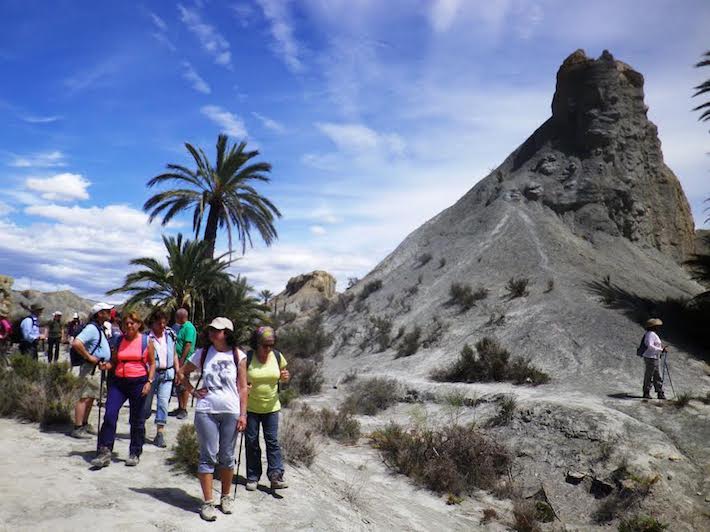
[71,303,113,438]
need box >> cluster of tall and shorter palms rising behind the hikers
[107,135,281,338]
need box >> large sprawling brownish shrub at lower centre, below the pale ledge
[371,423,512,495]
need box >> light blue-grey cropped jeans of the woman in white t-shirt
[195,412,239,473]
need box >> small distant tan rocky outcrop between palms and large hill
[270,270,337,313]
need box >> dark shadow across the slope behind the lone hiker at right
[585,281,710,362]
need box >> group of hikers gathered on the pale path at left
[6,303,289,521]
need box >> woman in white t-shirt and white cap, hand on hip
[178,318,247,521]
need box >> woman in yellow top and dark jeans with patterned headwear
[244,327,289,491]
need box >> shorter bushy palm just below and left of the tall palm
[106,234,231,321]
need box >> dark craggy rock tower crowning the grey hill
[500,50,695,262]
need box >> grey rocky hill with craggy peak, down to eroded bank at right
[316,51,710,530]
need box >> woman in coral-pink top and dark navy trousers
[91,312,155,468]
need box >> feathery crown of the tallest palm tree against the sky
[143,134,281,256]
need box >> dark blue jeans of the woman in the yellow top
[244,411,284,482]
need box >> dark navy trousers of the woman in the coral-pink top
[99,377,148,456]
